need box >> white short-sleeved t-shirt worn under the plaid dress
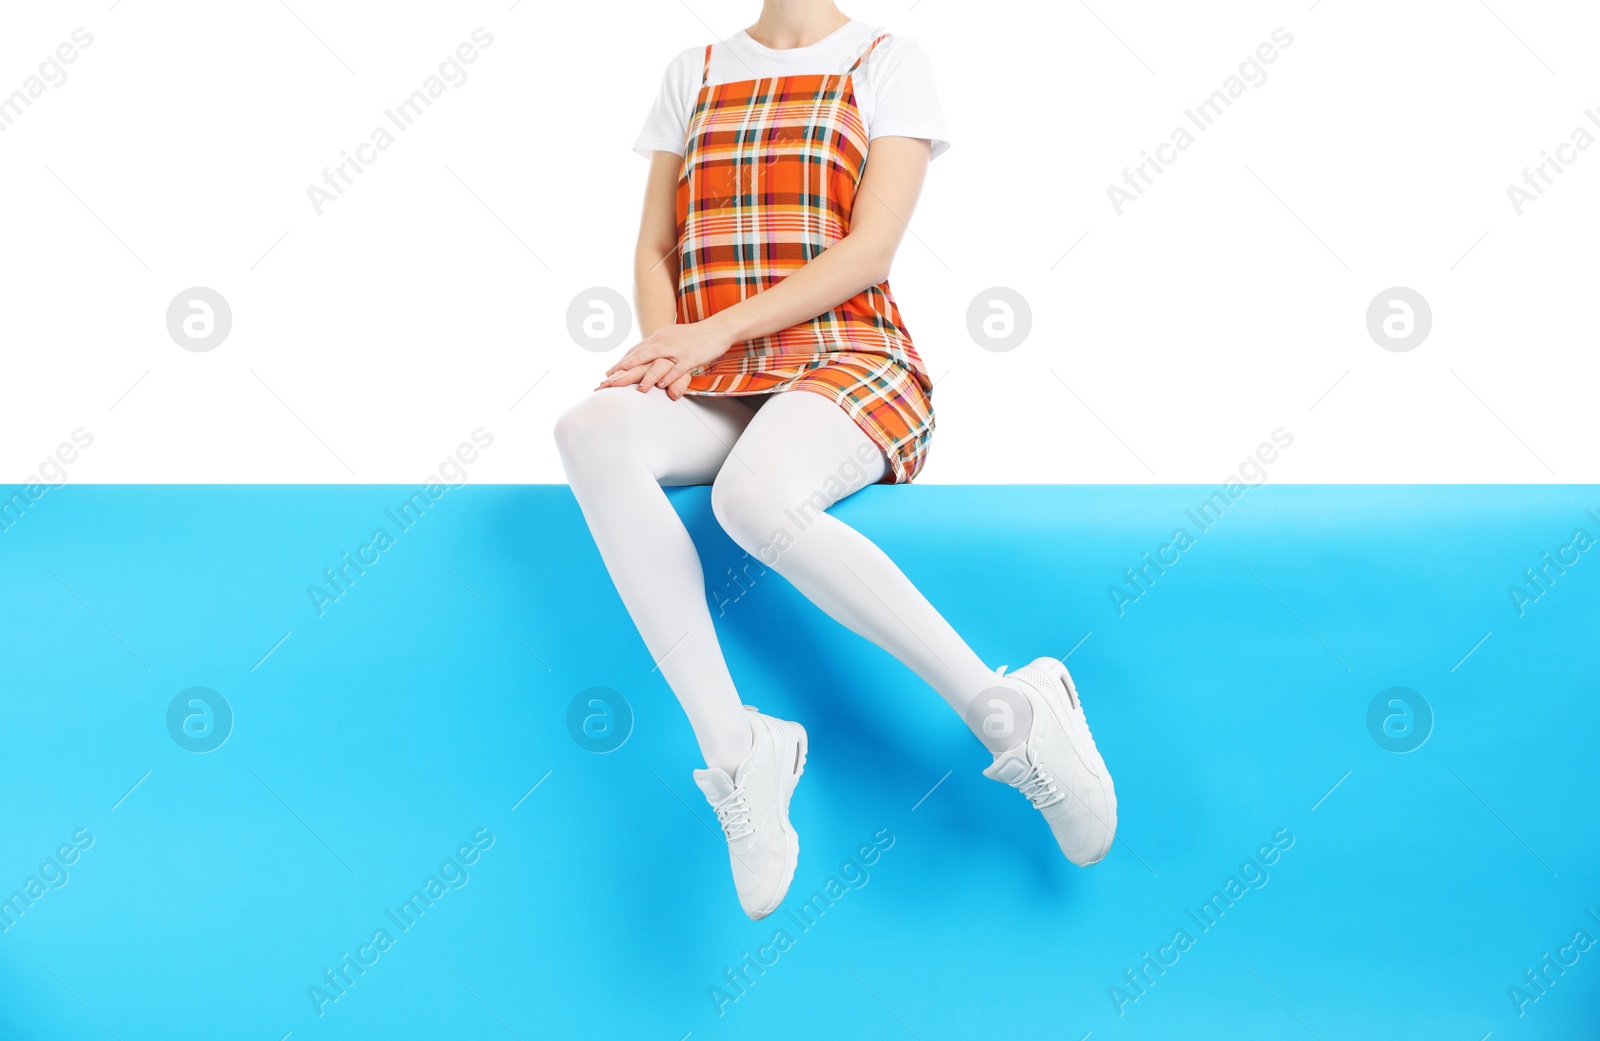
[634,19,950,158]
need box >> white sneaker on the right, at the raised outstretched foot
[984,657,1117,867]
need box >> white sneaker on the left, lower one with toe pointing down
[694,705,806,918]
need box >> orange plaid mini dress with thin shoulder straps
[677,34,934,485]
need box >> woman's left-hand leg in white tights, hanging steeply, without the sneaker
[555,387,755,774]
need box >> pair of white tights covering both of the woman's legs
[555,387,1002,776]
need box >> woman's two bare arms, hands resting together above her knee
[597,138,930,398]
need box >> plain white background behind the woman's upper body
[0,0,1600,483]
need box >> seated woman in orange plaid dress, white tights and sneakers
[555,0,1117,918]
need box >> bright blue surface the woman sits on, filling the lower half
[0,486,1600,1041]
